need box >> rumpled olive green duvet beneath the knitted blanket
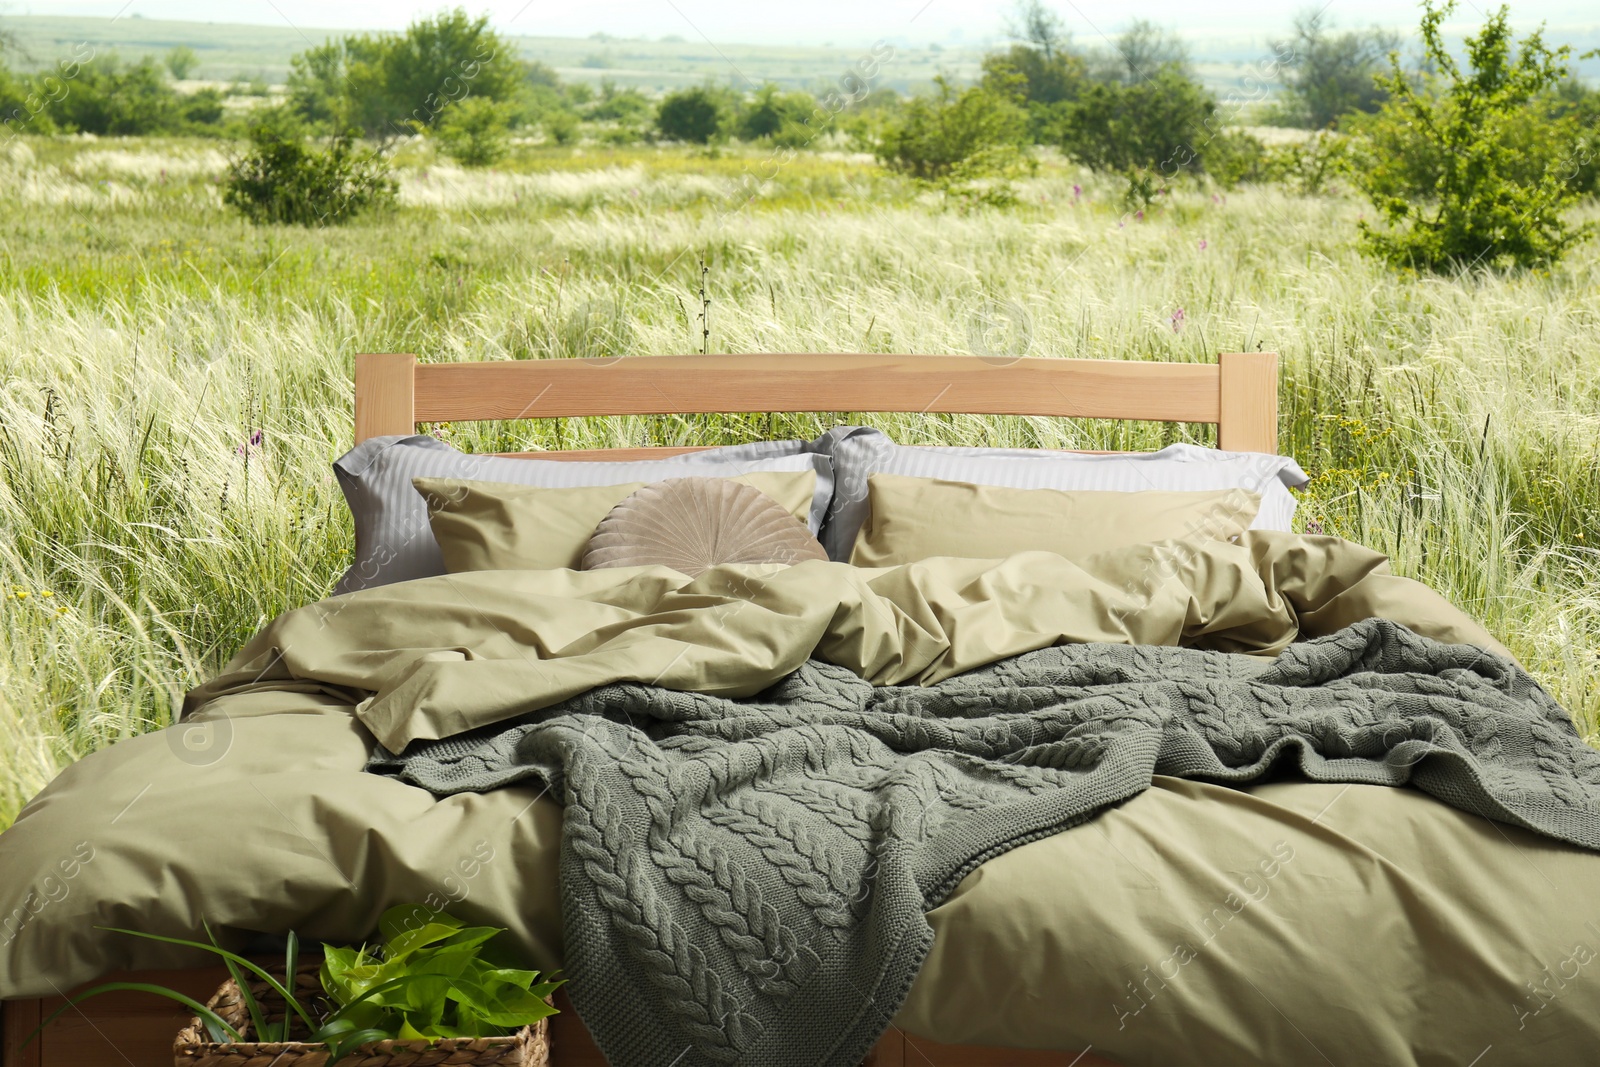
[0,534,1600,1064]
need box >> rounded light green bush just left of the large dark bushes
[877,77,1027,181]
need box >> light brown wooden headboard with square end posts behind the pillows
[355,352,1278,459]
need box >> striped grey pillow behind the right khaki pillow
[806,426,1310,561]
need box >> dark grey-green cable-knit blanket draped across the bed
[368,619,1600,1067]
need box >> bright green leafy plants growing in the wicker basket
[29,904,562,1067]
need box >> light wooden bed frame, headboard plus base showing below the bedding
[0,352,1278,1067]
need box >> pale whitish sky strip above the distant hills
[12,0,1600,46]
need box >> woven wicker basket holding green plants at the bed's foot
[173,966,550,1067]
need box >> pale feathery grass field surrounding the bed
[0,139,1600,825]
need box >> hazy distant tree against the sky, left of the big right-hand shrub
[1272,8,1400,130]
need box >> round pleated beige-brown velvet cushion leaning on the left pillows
[582,478,827,577]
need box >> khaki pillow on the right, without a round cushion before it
[850,474,1261,566]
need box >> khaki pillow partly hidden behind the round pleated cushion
[411,470,816,574]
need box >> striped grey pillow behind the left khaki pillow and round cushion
[333,435,834,593]
